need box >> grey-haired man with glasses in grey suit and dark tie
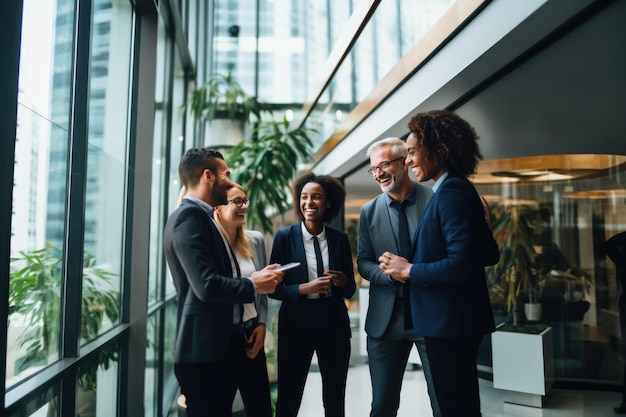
[357,138,436,417]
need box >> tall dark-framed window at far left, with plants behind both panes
[2,0,149,416]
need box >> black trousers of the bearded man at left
[174,334,245,417]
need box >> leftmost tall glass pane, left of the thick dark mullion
[6,0,74,387]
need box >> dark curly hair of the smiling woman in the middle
[292,171,346,224]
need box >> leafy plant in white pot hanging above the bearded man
[183,71,271,147]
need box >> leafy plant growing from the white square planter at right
[486,201,541,325]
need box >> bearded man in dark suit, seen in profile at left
[163,149,283,417]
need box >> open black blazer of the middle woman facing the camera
[270,223,356,332]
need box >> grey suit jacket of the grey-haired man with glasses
[356,182,433,337]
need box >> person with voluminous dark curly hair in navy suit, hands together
[379,110,499,417]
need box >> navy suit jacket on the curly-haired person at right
[410,175,499,338]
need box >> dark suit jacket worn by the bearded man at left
[163,199,255,363]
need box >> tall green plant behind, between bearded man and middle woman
[225,118,314,233]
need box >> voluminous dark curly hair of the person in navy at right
[407,110,483,177]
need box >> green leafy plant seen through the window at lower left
[9,242,119,388]
